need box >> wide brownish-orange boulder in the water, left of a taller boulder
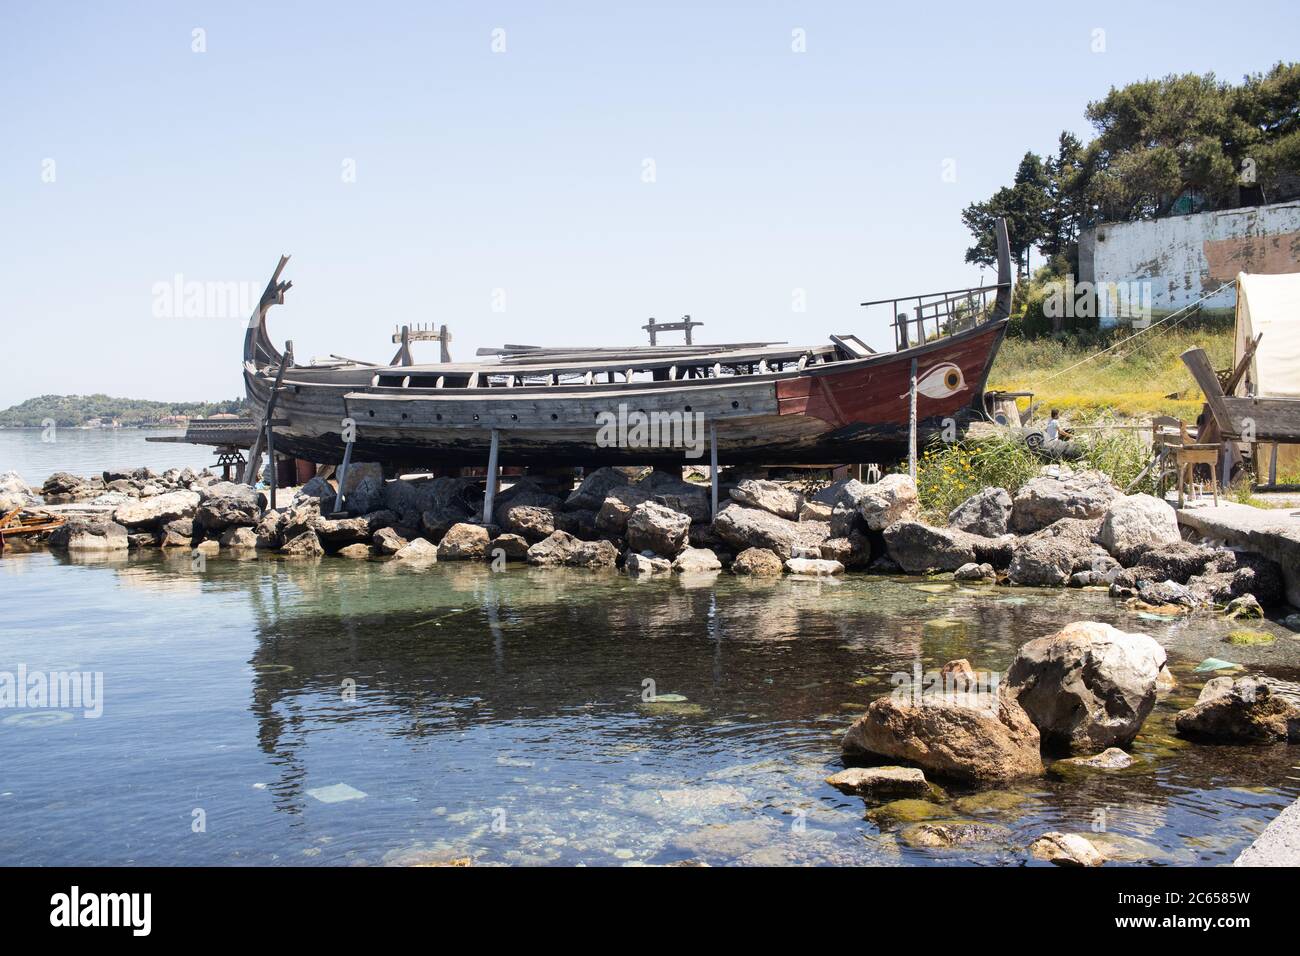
[841,692,1043,783]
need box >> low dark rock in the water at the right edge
[1174,678,1300,744]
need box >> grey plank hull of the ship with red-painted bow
[244,320,1006,468]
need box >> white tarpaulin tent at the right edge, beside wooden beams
[1232,272,1300,398]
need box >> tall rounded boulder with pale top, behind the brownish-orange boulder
[1006,620,1166,752]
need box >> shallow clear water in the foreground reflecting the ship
[0,551,1300,865]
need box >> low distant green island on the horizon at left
[0,395,248,428]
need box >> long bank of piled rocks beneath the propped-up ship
[0,464,1286,617]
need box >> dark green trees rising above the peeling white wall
[962,62,1300,276]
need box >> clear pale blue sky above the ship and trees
[0,0,1300,406]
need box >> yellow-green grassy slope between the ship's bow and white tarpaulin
[988,326,1232,421]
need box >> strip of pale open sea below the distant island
[0,428,216,490]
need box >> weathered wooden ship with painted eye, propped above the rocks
[243,221,1011,471]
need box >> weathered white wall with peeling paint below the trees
[1079,202,1300,326]
